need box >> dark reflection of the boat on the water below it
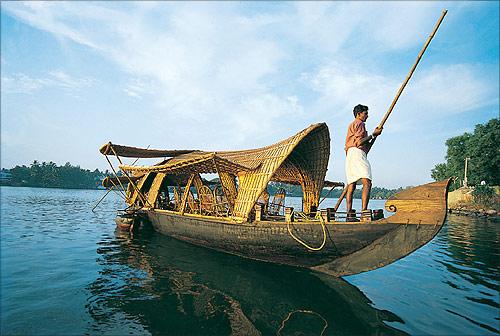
[86,229,404,335]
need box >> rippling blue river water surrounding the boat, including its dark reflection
[0,187,500,335]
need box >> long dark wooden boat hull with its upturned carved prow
[145,181,448,276]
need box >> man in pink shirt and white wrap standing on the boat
[345,104,382,220]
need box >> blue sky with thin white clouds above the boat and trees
[0,1,500,188]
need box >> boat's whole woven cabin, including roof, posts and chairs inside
[100,123,382,221]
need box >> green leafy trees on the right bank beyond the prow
[431,118,500,190]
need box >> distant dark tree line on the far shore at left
[2,160,109,189]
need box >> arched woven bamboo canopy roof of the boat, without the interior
[101,123,330,219]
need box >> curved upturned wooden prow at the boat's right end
[312,180,450,277]
